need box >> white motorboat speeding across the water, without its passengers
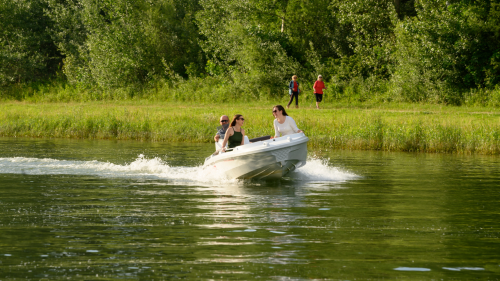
[204,133,309,180]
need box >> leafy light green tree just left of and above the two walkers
[197,0,299,94]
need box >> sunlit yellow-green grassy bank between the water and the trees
[0,100,500,155]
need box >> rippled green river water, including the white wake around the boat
[0,138,500,280]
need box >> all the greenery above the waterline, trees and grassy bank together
[0,0,500,155]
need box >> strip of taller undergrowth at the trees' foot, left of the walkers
[0,76,282,103]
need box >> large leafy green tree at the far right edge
[392,0,500,104]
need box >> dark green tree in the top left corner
[0,0,62,86]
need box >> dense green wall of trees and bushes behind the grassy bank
[0,0,500,105]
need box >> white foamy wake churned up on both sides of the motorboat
[0,155,357,184]
